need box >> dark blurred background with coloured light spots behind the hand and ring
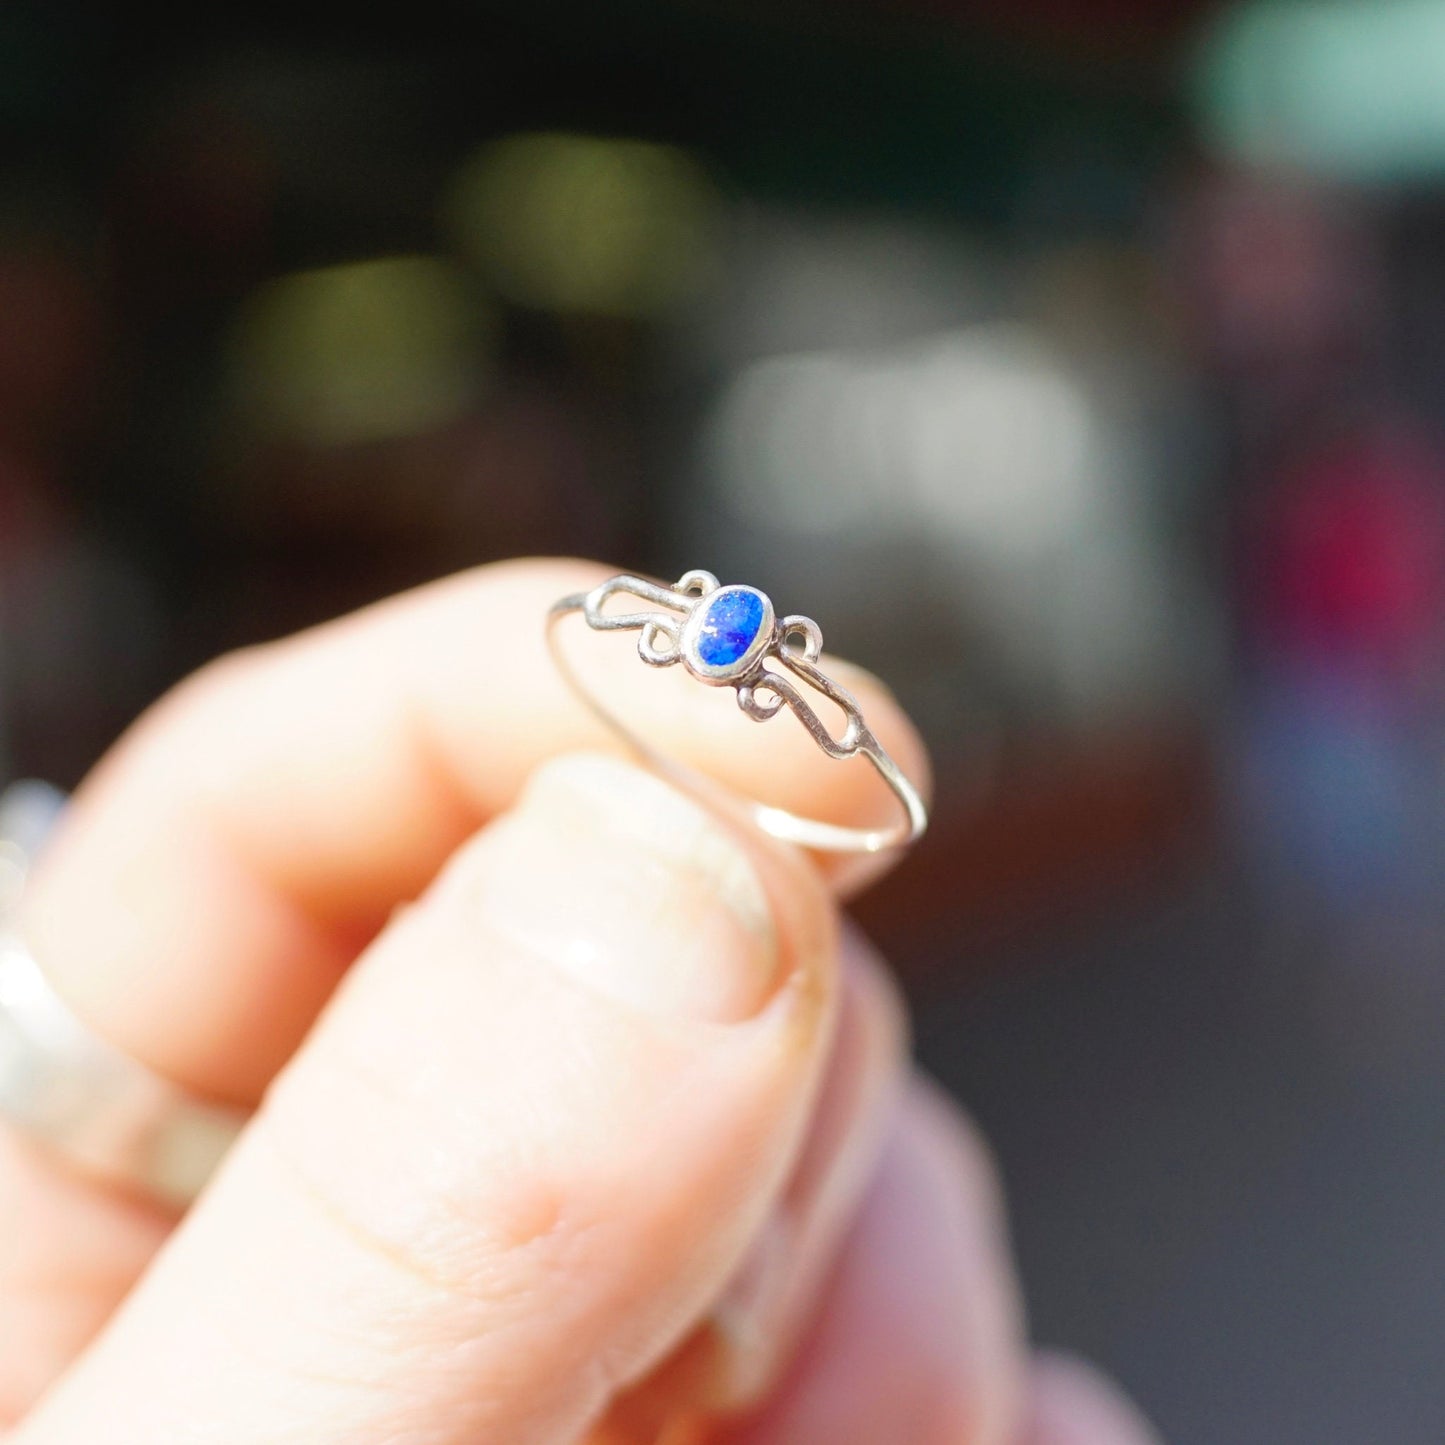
[0,0,1445,1445]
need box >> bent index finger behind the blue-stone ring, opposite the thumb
[26,561,925,1103]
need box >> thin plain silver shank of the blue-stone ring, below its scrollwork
[546,592,928,853]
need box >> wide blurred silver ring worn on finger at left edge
[0,785,244,1207]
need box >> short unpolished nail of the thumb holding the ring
[456,754,779,1023]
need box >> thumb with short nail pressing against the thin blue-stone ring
[17,756,834,1445]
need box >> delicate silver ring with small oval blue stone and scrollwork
[548,571,928,853]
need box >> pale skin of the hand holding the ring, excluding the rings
[0,562,1155,1445]
